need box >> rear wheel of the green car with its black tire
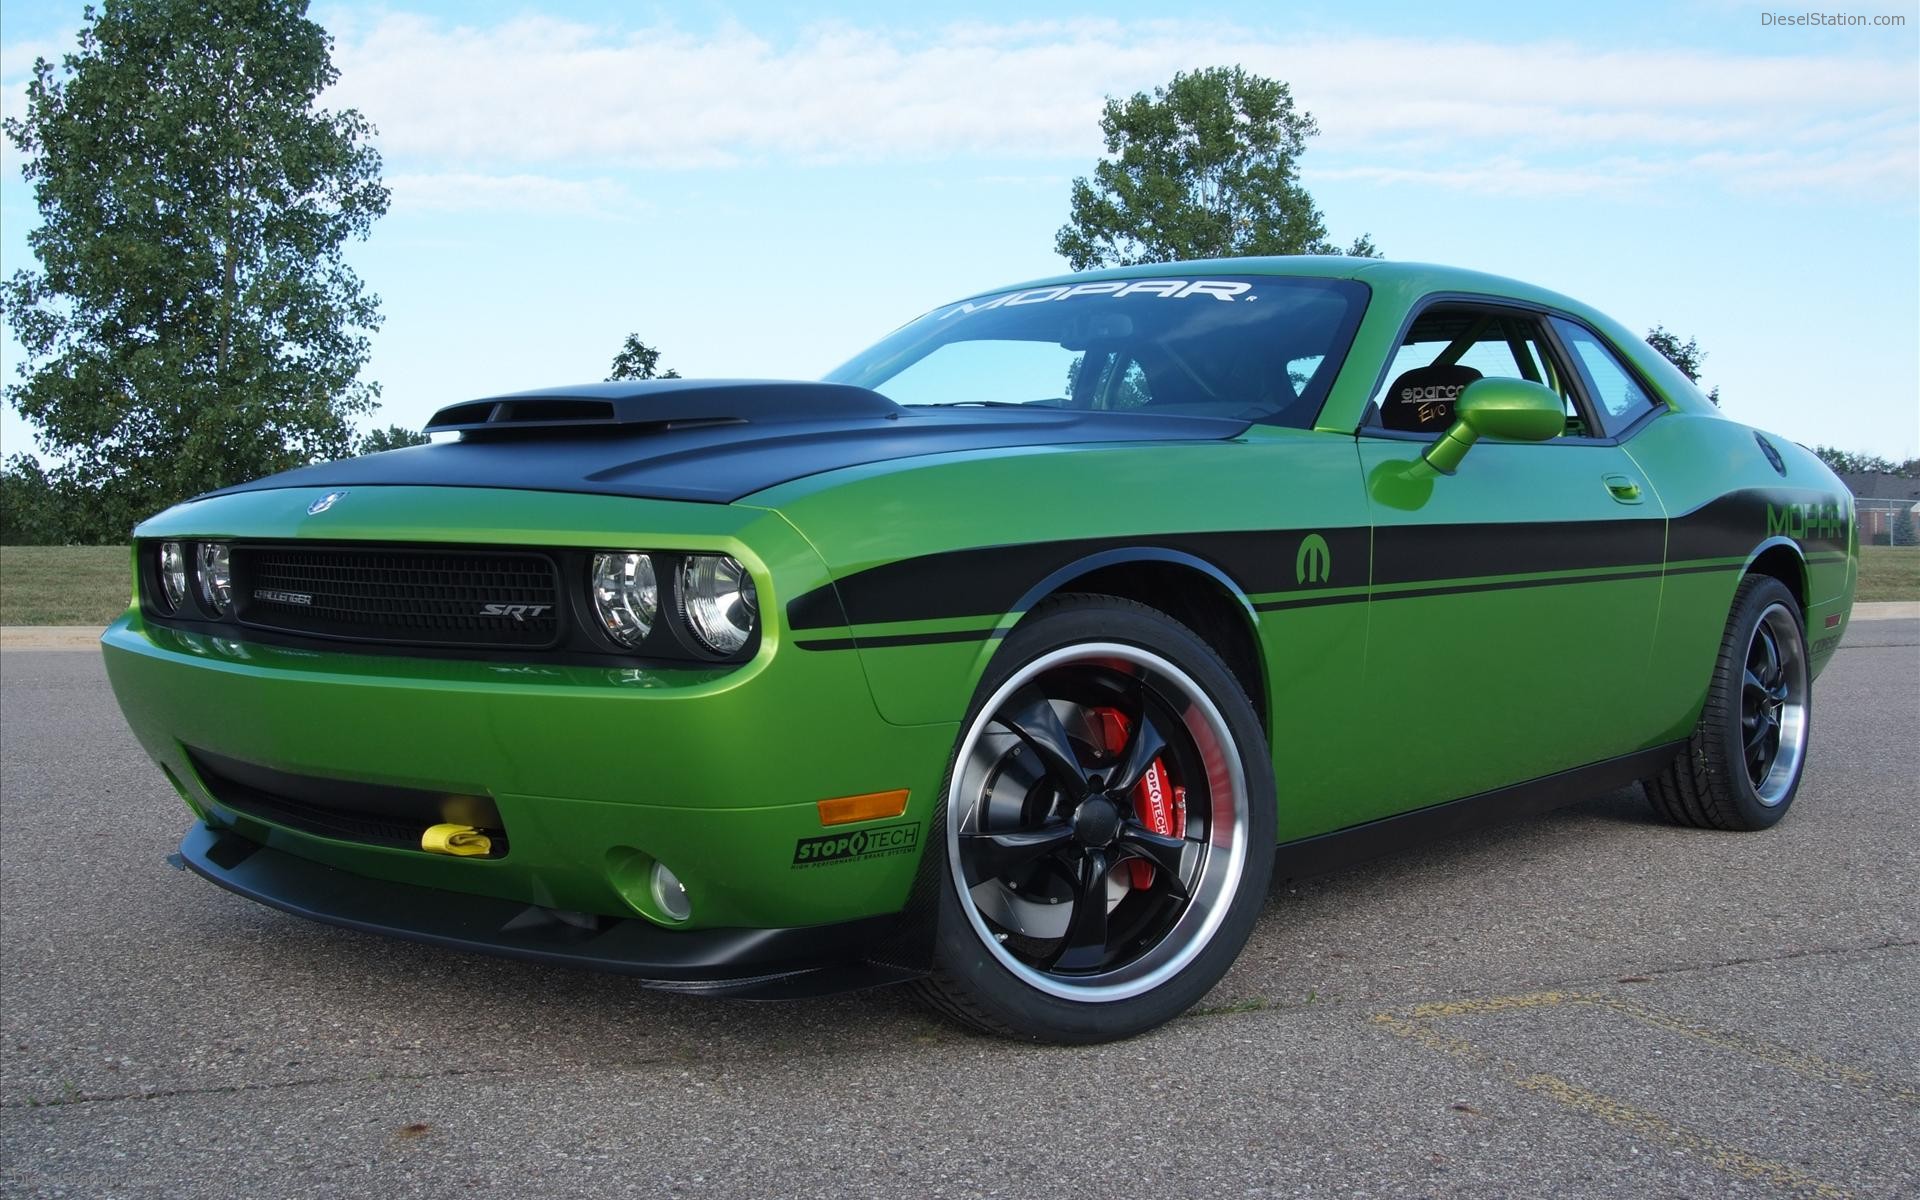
[1645,574,1812,829]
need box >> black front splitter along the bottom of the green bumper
[175,824,920,1000]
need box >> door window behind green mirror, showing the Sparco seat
[1373,305,1592,438]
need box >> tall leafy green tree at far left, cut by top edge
[0,0,388,538]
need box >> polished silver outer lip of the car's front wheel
[947,641,1248,1002]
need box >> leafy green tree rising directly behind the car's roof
[1054,67,1379,271]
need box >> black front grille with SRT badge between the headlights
[232,545,563,649]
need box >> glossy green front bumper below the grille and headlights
[102,612,952,935]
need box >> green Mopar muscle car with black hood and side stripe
[104,257,1859,1043]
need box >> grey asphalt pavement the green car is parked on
[0,620,1920,1200]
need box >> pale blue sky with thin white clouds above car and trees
[0,0,1920,457]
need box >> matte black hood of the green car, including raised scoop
[209,380,1250,503]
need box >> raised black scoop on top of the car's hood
[426,378,900,440]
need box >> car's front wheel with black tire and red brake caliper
[916,595,1275,1044]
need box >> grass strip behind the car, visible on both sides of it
[0,545,1920,626]
